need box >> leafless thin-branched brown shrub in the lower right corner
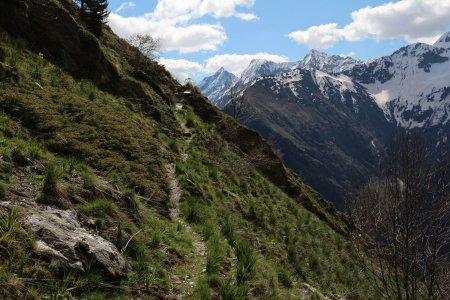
[350,134,450,299]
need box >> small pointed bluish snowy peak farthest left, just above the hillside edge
[199,68,238,104]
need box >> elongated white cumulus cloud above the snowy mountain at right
[288,0,450,49]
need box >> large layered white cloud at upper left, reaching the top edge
[108,0,258,53]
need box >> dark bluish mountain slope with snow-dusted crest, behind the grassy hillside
[225,69,392,209]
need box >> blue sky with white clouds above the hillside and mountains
[109,0,450,80]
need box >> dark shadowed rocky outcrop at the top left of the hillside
[0,0,119,86]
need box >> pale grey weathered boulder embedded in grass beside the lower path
[25,207,127,277]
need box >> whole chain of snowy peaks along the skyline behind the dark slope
[200,32,450,132]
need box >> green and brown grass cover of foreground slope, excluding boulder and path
[0,1,376,299]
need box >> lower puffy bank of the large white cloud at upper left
[108,13,227,53]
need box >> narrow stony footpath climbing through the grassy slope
[166,113,206,299]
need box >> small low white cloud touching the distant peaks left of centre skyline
[205,53,288,76]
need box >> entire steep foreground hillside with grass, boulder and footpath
[0,0,378,299]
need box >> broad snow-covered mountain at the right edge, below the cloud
[344,33,450,128]
